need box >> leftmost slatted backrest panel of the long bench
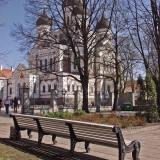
[10,113,39,131]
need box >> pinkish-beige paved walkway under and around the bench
[0,109,160,160]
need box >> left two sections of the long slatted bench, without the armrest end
[10,113,70,147]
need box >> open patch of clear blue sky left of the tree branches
[0,0,26,69]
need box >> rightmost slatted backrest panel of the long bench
[66,121,118,147]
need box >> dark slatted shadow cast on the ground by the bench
[0,138,107,160]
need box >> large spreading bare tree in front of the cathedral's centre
[12,0,118,112]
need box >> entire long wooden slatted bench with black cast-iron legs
[10,113,140,160]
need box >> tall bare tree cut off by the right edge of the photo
[128,0,160,113]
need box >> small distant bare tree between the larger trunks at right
[119,37,142,93]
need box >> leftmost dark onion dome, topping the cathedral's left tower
[36,8,52,26]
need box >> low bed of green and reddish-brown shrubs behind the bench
[42,110,146,128]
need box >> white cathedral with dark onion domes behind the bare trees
[3,0,113,105]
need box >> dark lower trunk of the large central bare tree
[82,76,89,113]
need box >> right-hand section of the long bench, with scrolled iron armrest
[66,120,140,160]
